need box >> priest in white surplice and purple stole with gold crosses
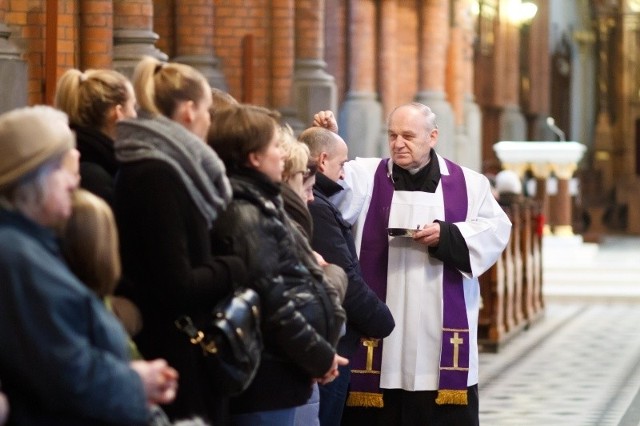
[314,103,511,426]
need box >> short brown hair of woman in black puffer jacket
[207,105,280,170]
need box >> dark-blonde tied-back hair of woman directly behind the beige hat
[54,69,131,129]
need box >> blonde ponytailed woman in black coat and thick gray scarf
[114,57,246,424]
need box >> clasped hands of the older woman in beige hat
[131,359,178,404]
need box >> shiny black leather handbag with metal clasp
[175,288,263,396]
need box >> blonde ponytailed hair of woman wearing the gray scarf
[132,56,211,118]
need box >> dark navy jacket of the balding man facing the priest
[309,173,395,358]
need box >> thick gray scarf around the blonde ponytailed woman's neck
[115,113,232,226]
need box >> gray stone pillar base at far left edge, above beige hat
[0,0,28,113]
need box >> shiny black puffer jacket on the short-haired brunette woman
[212,169,335,413]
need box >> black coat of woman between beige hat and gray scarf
[71,125,119,206]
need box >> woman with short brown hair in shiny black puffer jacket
[208,106,346,426]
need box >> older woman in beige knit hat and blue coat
[0,106,177,425]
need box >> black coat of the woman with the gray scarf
[115,160,246,424]
